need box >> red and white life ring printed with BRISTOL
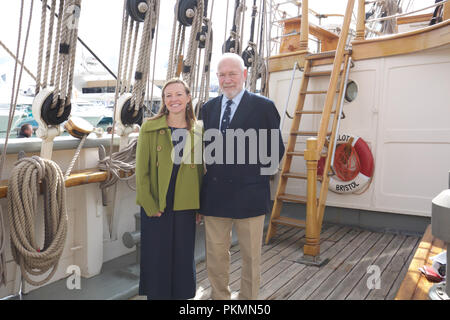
[328,134,375,193]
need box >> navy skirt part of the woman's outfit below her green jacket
[139,208,196,300]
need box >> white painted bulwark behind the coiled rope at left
[0,134,139,298]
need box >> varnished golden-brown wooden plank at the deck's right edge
[395,225,433,300]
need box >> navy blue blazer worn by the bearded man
[200,91,284,219]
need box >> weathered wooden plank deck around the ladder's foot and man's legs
[195,225,420,300]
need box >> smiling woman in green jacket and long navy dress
[136,79,203,299]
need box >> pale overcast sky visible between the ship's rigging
[0,0,434,90]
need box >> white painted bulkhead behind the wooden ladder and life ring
[269,45,450,217]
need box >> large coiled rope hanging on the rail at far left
[8,156,67,286]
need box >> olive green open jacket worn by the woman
[136,116,203,216]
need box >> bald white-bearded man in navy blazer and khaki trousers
[201,53,284,299]
